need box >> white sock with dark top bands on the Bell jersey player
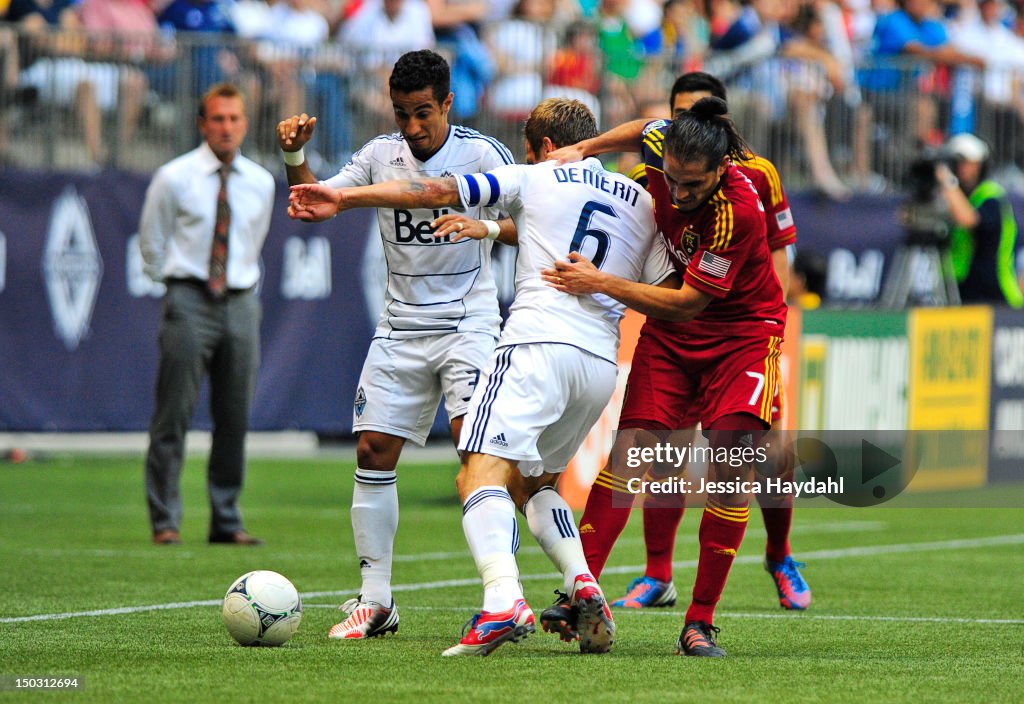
[351,469,398,606]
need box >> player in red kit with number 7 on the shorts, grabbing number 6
[542,97,786,657]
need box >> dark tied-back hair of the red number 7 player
[665,97,751,170]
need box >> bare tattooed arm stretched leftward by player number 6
[288,177,460,222]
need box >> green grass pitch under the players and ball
[0,455,1024,704]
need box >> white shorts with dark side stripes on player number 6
[459,343,618,477]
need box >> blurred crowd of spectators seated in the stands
[0,0,1024,192]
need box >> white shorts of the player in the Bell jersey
[352,333,495,445]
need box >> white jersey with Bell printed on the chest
[325,125,514,340]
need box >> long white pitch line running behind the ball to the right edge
[0,533,1024,623]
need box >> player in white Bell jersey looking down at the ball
[278,51,514,640]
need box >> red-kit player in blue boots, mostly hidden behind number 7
[610,71,811,610]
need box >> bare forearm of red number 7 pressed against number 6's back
[541,252,712,322]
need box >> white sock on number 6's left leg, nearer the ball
[462,486,522,612]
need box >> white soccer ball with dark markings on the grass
[220,570,302,646]
